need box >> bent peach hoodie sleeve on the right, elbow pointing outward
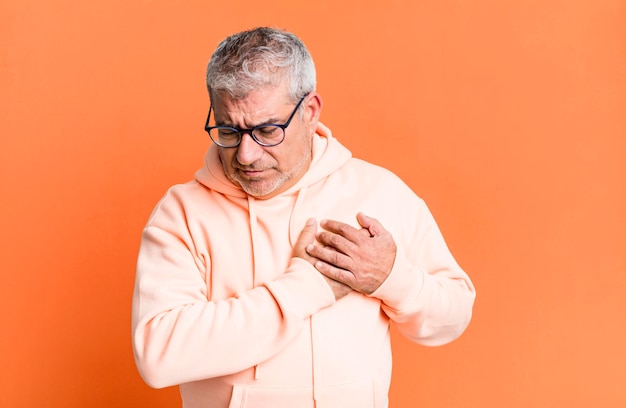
[371,199,476,346]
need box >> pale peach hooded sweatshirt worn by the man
[133,124,475,408]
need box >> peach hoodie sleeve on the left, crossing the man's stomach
[132,202,334,388]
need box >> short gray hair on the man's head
[206,27,316,103]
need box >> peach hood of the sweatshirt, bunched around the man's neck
[196,123,352,198]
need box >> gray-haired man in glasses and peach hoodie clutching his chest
[133,28,475,408]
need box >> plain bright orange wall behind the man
[0,0,626,408]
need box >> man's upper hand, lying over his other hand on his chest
[306,213,397,295]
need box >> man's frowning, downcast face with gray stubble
[213,84,321,198]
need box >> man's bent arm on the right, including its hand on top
[307,200,475,345]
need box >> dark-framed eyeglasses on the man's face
[204,93,308,147]
